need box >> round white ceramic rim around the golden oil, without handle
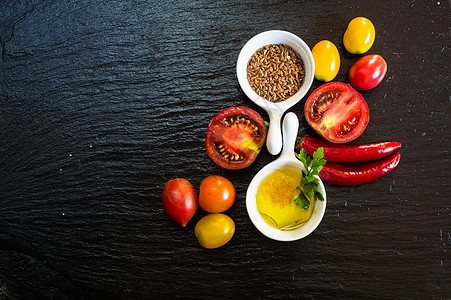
[246,159,327,242]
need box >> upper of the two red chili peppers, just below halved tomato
[300,136,401,163]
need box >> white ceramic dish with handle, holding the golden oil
[246,112,327,241]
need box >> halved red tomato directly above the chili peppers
[304,82,370,144]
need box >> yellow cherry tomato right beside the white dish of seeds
[312,40,340,82]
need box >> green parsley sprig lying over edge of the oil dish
[294,147,326,209]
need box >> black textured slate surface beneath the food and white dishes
[0,0,451,299]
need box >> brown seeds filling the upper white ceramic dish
[247,44,305,102]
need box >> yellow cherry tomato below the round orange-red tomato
[194,213,235,249]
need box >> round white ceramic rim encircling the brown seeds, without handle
[236,30,315,113]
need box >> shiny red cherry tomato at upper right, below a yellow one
[349,54,387,90]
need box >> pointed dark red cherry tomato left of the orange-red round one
[162,178,197,227]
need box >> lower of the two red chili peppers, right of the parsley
[319,153,401,185]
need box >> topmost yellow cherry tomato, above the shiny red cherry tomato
[343,17,376,54]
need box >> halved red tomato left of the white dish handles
[205,106,267,169]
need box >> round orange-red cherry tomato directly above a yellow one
[199,175,236,213]
